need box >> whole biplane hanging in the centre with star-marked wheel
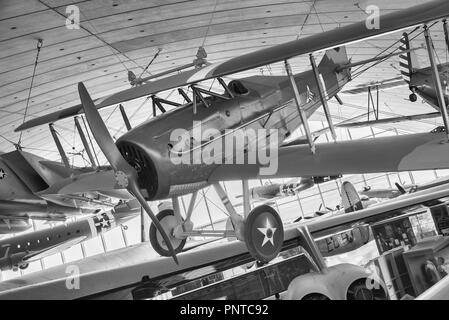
[16,0,449,262]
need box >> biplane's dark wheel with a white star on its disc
[244,205,284,262]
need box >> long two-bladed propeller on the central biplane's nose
[78,82,178,264]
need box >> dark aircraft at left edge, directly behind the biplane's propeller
[0,150,140,234]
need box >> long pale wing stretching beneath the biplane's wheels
[0,182,449,300]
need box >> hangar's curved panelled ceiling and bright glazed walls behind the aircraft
[0,0,449,300]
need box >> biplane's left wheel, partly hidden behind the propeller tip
[150,209,187,257]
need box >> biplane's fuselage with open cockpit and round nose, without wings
[117,48,351,200]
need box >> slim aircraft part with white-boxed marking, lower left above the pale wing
[0,203,140,270]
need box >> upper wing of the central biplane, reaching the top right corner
[15,0,449,131]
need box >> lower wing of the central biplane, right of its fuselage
[208,129,449,183]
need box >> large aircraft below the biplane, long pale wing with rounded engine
[0,182,449,300]
